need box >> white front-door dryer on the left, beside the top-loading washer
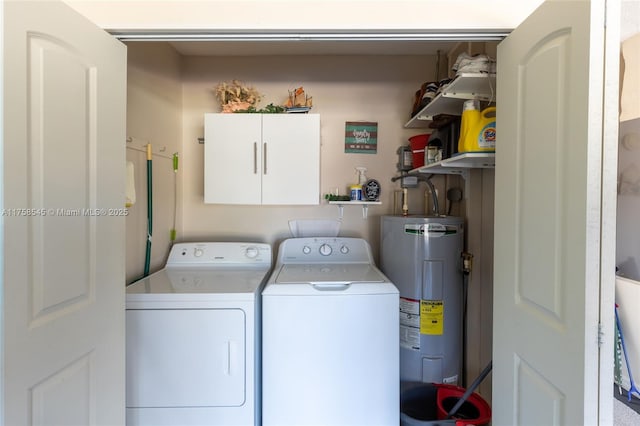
[126,243,272,426]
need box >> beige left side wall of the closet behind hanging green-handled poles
[126,43,182,282]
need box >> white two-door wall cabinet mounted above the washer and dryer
[204,113,320,205]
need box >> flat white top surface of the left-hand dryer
[127,267,269,296]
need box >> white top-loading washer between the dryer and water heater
[262,237,400,426]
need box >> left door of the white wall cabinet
[204,114,262,204]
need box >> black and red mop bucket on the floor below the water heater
[400,382,491,426]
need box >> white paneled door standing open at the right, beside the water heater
[493,0,619,425]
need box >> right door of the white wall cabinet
[262,114,320,204]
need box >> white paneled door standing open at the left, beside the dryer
[0,1,126,425]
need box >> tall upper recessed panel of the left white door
[27,34,97,325]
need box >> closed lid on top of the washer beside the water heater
[274,263,388,284]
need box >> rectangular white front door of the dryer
[126,309,245,408]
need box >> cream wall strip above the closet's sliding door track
[65,0,542,30]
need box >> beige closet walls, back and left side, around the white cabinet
[127,42,464,266]
